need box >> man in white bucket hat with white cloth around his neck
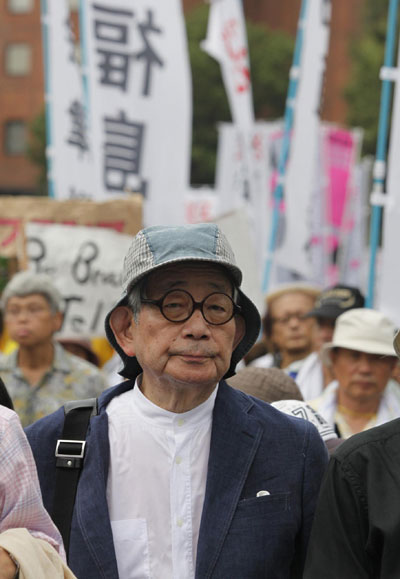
[310,308,400,438]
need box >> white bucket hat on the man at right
[321,308,400,365]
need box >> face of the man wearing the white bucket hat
[331,348,396,402]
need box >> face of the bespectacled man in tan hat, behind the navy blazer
[270,292,315,355]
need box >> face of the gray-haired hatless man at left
[4,294,62,347]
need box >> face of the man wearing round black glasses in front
[115,263,244,386]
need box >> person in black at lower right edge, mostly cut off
[304,334,400,579]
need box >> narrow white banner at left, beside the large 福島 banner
[42,0,94,199]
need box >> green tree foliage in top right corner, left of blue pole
[345,0,389,155]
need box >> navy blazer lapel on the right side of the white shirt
[196,382,262,578]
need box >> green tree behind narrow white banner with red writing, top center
[186,5,294,185]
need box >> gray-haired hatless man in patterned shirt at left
[0,271,108,426]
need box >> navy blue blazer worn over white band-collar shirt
[26,380,327,579]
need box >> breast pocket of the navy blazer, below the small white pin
[230,492,291,532]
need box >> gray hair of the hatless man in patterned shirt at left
[0,271,64,313]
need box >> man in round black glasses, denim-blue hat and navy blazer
[27,224,327,579]
